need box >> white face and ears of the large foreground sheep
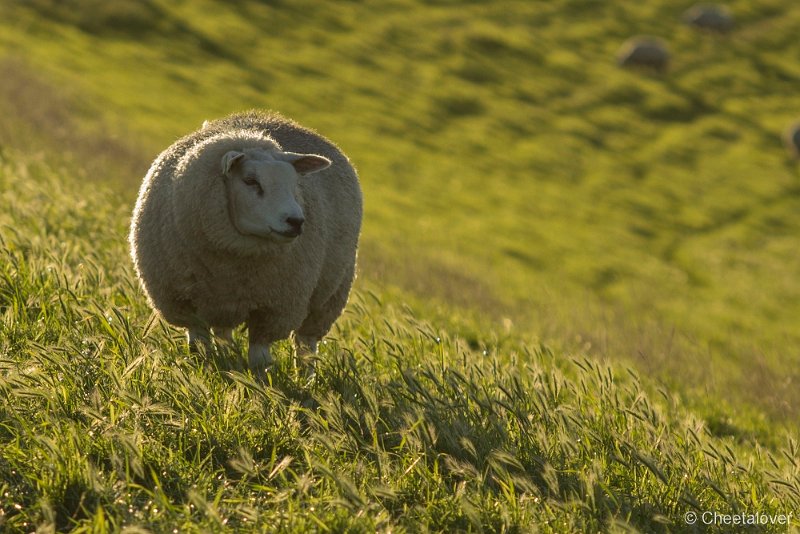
[222,150,331,243]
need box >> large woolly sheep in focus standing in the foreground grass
[129,111,362,375]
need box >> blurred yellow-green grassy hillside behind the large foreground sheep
[0,0,800,430]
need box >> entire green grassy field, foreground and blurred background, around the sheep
[0,0,800,532]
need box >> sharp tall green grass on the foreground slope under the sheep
[0,150,800,532]
